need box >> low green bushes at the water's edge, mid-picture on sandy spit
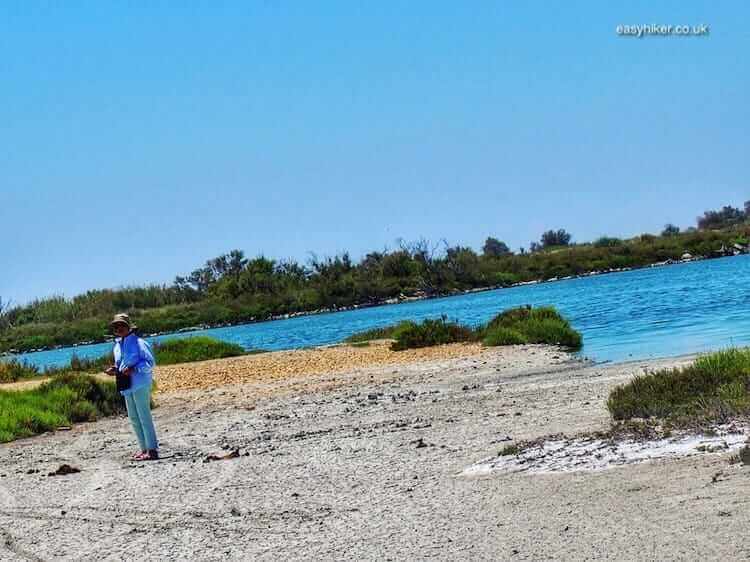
[345,306,583,351]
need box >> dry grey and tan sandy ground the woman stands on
[0,346,750,560]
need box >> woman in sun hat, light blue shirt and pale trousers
[107,314,159,461]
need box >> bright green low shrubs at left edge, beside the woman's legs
[0,373,125,443]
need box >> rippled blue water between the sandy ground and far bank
[8,256,750,367]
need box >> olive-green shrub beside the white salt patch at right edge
[607,348,750,426]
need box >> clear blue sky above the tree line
[0,0,750,303]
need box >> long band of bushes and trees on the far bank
[0,199,750,351]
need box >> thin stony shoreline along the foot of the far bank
[0,253,746,359]
